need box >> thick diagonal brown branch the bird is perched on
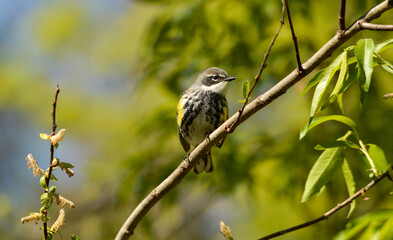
[116,0,393,240]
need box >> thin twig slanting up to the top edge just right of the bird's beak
[226,0,285,133]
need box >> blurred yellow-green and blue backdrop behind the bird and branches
[0,0,393,240]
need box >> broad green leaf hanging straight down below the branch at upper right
[355,39,374,103]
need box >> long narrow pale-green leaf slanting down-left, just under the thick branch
[310,53,344,119]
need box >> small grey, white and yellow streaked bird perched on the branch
[177,67,236,173]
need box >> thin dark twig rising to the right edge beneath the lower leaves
[258,171,389,240]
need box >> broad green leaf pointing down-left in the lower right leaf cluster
[302,147,345,202]
